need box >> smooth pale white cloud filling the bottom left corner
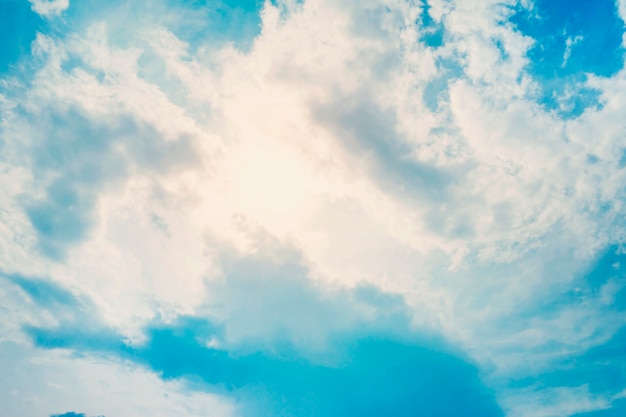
[0,343,236,417]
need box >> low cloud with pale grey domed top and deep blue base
[17,236,501,416]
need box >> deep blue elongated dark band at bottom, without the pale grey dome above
[23,296,502,416]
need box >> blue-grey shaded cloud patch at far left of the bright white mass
[0,29,205,258]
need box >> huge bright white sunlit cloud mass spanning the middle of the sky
[0,0,626,416]
